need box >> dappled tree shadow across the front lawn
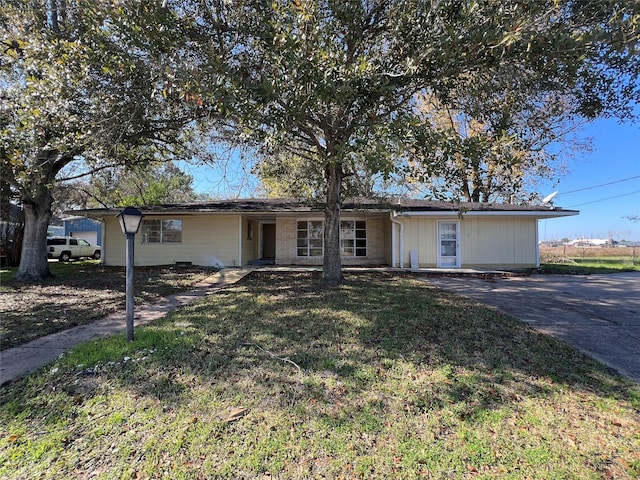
[0,272,638,450]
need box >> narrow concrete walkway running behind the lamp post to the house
[0,268,252,385]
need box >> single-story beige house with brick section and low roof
[73,198,579,269]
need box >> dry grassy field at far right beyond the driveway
[540,246,640,274]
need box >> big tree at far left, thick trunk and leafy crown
[0,0,215,280]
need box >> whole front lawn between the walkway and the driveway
[0,272,640,479]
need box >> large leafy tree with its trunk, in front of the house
[178,0,640,284]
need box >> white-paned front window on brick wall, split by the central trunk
[297,220,367,257]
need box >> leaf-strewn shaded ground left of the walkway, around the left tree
[0,260,213,350]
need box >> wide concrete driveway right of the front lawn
[426,272,640,383]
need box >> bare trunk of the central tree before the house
[322,164,343,287]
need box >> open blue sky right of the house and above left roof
[180,119,640,241]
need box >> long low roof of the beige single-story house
[66,198,580,219]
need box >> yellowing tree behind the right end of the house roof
[401,88,589,203]
